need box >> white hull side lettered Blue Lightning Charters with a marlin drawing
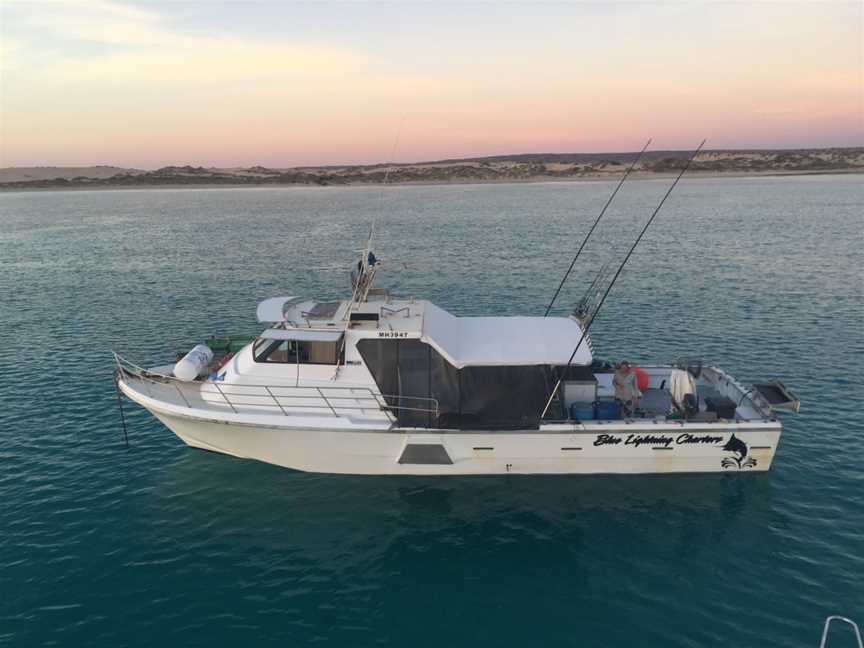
[145,411,780,475]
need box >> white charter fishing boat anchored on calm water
[114,244,800,475]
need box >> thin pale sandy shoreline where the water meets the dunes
[0,167,864,193]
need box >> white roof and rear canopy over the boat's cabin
[259,297,592,368]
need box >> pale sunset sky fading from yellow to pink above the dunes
[0,0,864,169]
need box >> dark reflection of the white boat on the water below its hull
[141,450,772,559]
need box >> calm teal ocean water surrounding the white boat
[0,176,864,648]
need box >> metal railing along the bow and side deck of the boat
[112,352,438,422]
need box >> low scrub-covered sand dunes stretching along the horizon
[0,147,864,189]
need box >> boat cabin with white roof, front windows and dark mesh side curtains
[246,291,592,430]
